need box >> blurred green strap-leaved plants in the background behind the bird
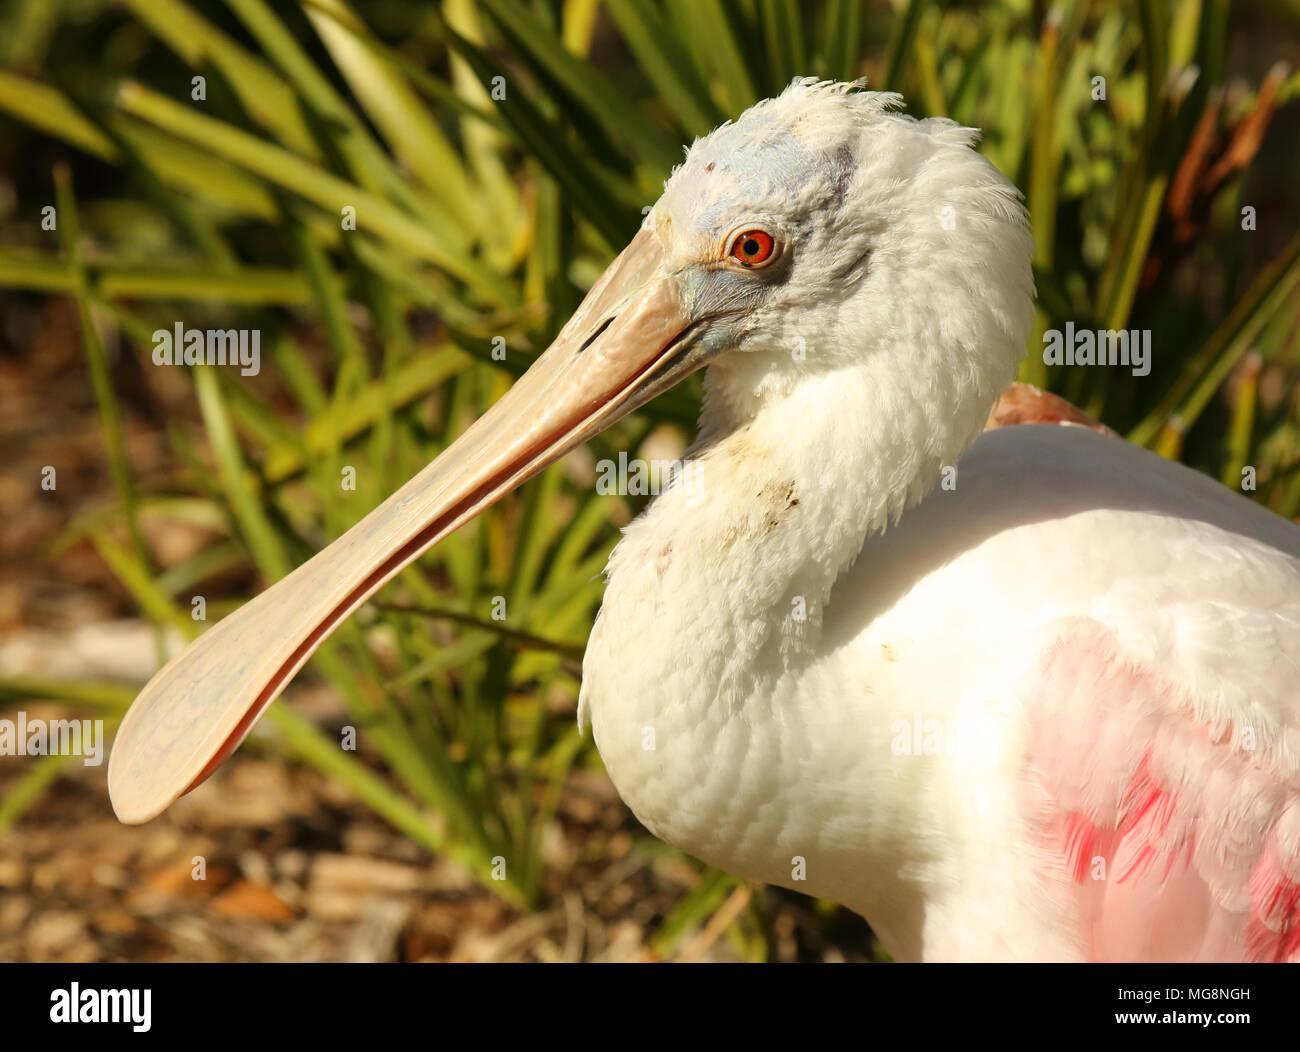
[0,0,1300,960]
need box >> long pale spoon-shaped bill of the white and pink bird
[108,228,702,823]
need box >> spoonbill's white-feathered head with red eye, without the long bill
[562,78,1034,419]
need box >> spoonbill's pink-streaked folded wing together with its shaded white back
[826,427,1300,960]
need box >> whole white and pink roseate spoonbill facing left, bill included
[108,79,1300,961]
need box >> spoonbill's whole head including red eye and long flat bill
[108,79,1032,822]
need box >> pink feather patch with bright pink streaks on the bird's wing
[1024,622,1300,961]
